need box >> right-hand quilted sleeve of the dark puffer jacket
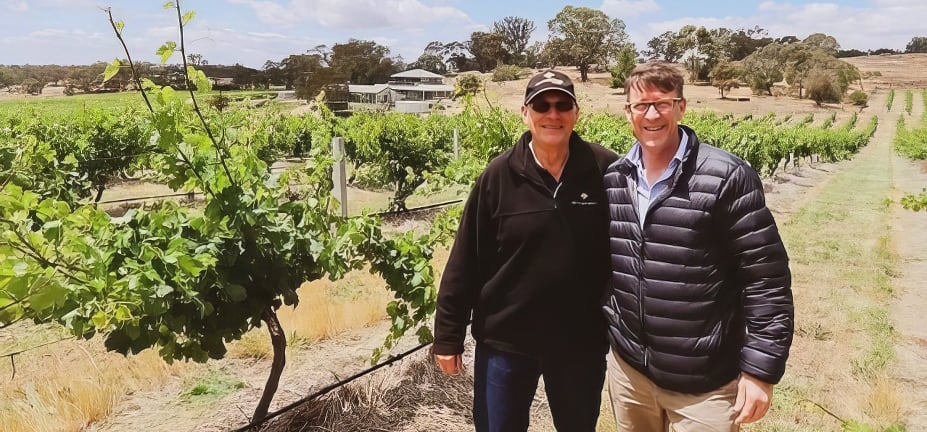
[721,163,794,384]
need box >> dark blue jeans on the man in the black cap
[473,345,605,432]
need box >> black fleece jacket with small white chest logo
[434,132,618,356]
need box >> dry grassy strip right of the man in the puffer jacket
[746,124,903,431]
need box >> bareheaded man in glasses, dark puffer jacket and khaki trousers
[603,62,794,432]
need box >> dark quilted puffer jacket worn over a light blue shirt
[603,126,794,393]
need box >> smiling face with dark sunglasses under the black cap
[521,90,579,146]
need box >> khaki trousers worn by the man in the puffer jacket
[606,352,740,432]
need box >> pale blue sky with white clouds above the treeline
[0,0,927,69]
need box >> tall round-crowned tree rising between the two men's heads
[547,6,629,81]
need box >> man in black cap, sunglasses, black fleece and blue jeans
[434,70,618,432]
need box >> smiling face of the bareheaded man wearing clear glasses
[625,85,686,153]
